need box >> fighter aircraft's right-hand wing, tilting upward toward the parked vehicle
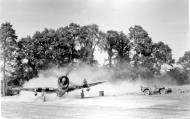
[67,81,105,92]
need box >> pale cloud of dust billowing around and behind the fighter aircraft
[17,63,178,101]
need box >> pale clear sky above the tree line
[0,0,190,59]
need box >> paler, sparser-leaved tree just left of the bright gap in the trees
[78,24,102,64]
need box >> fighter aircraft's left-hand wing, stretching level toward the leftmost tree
[12,87,58,93]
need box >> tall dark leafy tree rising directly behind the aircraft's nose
[55,23,80,63]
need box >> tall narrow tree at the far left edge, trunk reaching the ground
[0,22,17,95]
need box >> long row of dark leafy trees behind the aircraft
[0,22,190,86]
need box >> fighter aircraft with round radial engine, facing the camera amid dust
[13,75,104,101]
